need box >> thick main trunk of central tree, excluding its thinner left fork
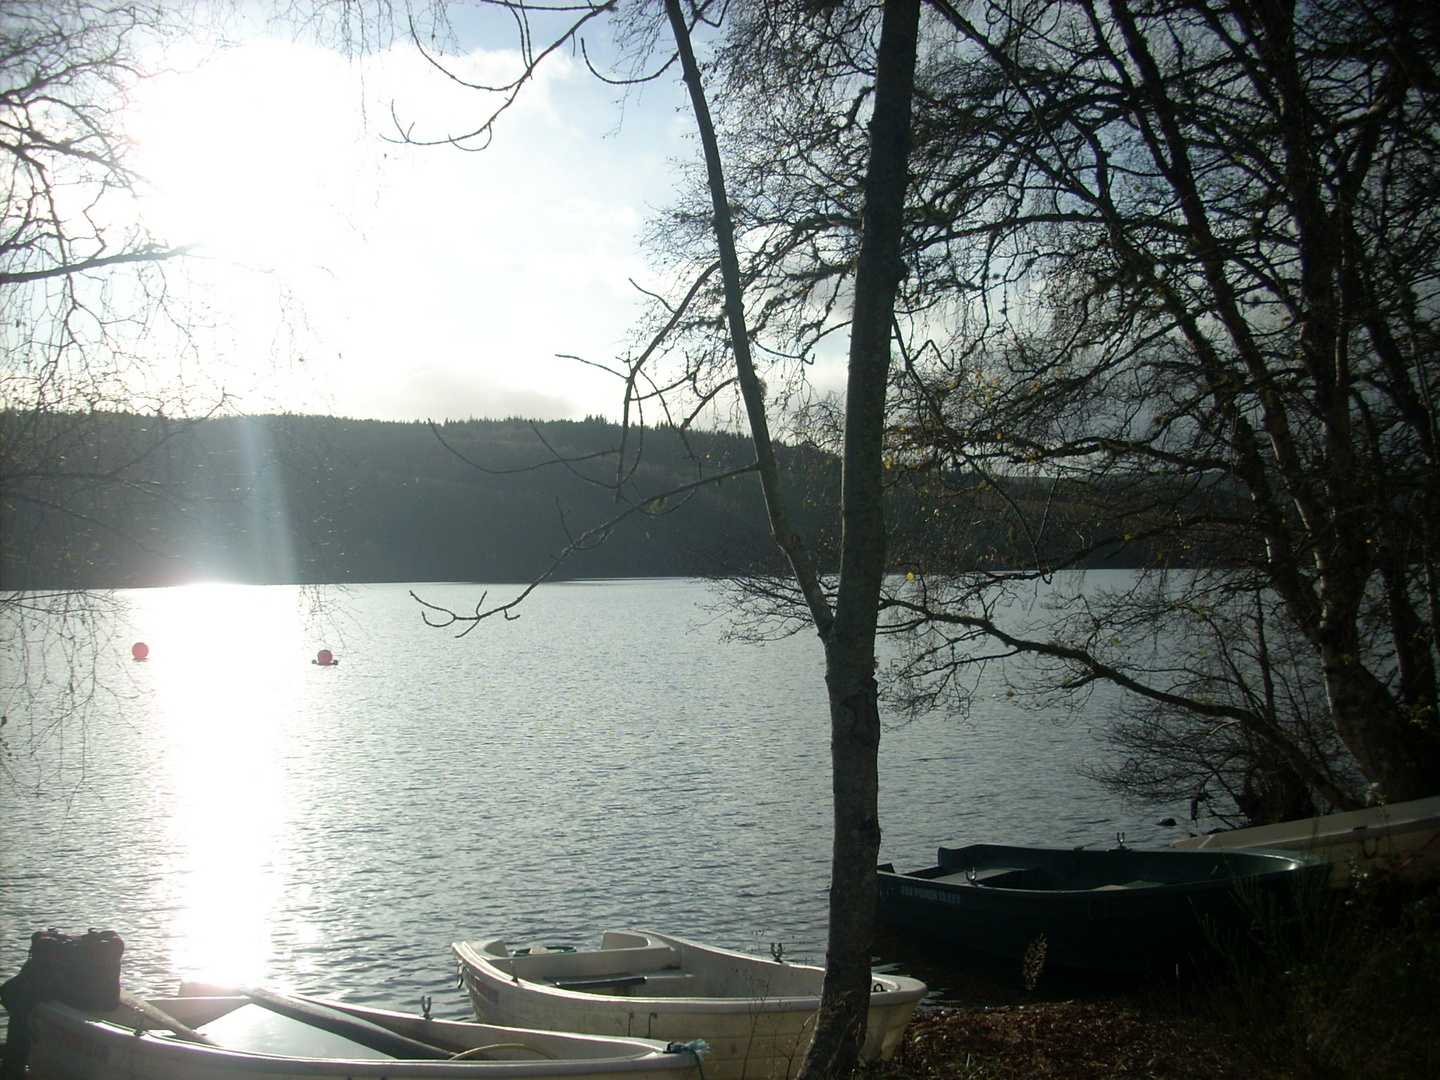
[799,0,920,1080]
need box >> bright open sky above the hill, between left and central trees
[128,8,698,420]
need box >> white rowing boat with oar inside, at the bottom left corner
[29,991,698,1080]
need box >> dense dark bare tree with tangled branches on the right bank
[897,0,1440,818]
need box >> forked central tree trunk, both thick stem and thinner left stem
[665,0,920,1080]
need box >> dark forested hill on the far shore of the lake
[0,412,1203,589]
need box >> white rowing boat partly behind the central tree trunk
[452,930,926,1080]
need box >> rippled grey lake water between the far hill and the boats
[0,579,1179,1017]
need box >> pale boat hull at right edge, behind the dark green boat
[1171,796,1440,888]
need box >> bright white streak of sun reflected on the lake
[135,585,308,982]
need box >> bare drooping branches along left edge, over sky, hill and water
[0,0,204,789]
